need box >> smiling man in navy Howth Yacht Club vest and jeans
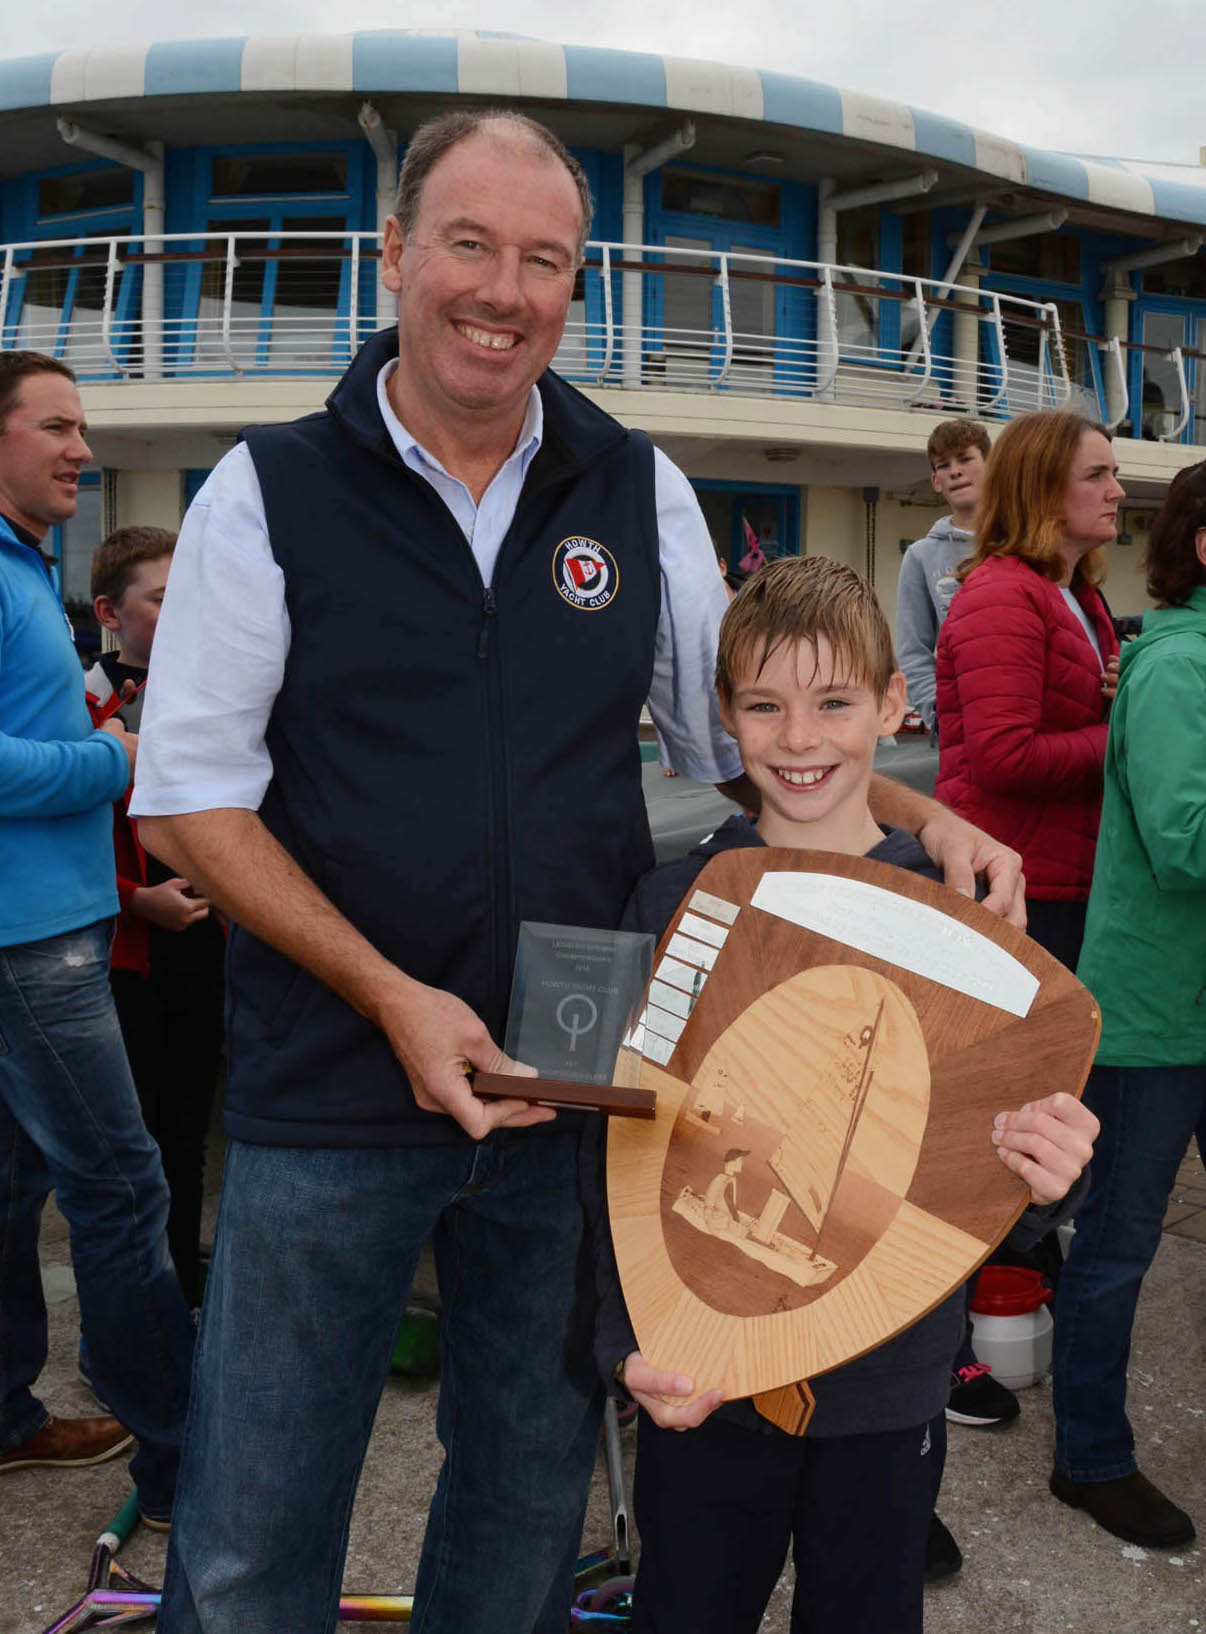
[132,113,1013,1634]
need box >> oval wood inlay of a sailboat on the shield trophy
[663,964,930,1312]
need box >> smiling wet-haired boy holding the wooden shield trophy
[583,557,1097,1634]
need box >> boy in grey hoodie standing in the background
[896,420,992,732]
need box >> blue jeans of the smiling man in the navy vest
[159,1131,601,1634]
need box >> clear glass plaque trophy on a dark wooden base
[474,920,657,1116]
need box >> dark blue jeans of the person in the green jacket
[1054,1067,1206,1482]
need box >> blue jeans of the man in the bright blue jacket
[0,923,193,1515]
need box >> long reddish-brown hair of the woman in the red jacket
[958,413,1110,585]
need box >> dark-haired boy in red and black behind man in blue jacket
[85,528,224,1306]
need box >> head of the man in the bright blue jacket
[0,369,92,539]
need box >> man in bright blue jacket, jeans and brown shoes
[0,351,191,1523]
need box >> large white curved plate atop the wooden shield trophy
[750,873,1039,1016]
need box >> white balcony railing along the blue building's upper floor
[0,229,1190,440]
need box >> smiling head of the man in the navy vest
[382,126,582,430]
